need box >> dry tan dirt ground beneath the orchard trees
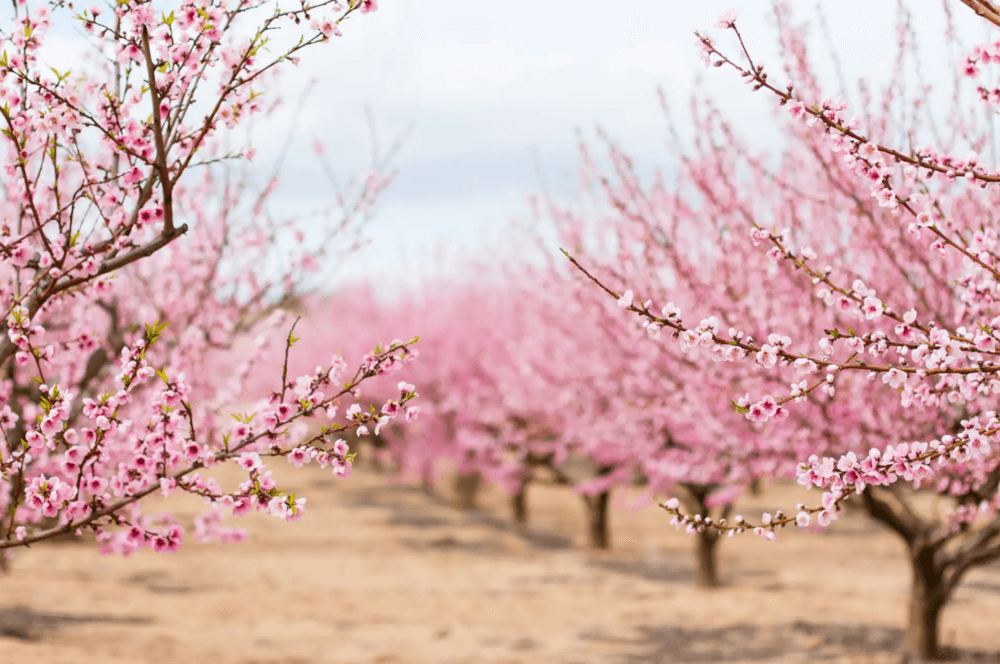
[0,468,1000,664]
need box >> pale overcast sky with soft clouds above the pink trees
[35,0,995,294]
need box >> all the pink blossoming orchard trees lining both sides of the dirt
[0,0,1000,657]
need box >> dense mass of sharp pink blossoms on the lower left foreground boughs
[0,327,416,554]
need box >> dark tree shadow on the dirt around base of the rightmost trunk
[612,621,1000,664]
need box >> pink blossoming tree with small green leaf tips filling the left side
[0,0,415,564]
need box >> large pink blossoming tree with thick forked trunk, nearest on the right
[574,0,1000,657]
